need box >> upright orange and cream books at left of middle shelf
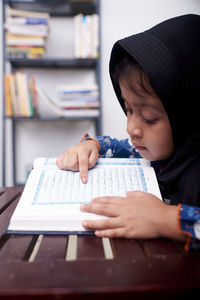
[4,72,38,117]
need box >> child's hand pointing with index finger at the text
[56,140,99,183]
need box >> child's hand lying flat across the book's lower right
[81,191,188,240]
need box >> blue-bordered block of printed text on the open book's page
[31,158,158,205]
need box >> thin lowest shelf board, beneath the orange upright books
[4,116,99,122]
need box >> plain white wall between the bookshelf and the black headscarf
[101,0,200,138]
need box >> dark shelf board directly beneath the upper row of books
[6,57,97,69]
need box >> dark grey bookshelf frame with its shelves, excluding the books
[2,0,101,186]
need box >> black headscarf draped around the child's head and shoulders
[110,14,200,206]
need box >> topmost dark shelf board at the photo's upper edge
[4,0,97,16]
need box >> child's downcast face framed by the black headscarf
[119,78,174,161]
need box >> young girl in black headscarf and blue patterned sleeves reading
[57,15,200,248]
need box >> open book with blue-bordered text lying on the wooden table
[8,158,161,233]
